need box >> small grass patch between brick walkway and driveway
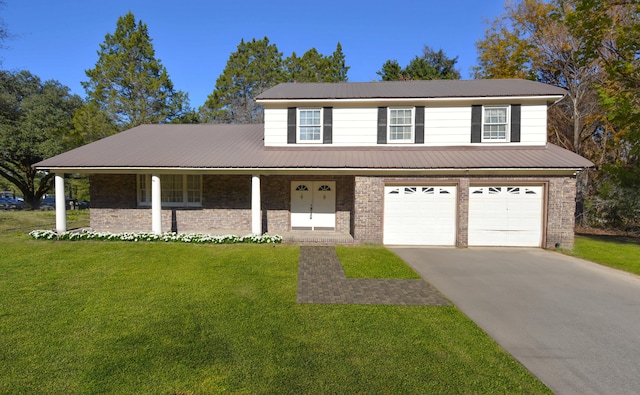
[336,245,420,279]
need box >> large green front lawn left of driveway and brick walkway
[0,236,549,394]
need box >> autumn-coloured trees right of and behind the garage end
[475,0,640,231]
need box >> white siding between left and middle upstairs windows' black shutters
[333,108,378,146]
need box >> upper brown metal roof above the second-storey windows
[257,79,566,101]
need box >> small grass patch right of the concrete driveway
[571,236,640,275]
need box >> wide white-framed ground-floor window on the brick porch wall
[136,174,202,207]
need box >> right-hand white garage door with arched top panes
[468,186,544,247]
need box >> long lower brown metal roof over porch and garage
[35,124,593,173]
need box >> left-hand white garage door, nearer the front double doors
[383,186,457,245]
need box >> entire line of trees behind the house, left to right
[0,0,640,234]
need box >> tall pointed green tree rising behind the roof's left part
[82,12,188,130]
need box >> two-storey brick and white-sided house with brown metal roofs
[37,79,593,247]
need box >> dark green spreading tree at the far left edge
[0,71,82,209]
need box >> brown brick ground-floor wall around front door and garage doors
[91,174,576,248]
